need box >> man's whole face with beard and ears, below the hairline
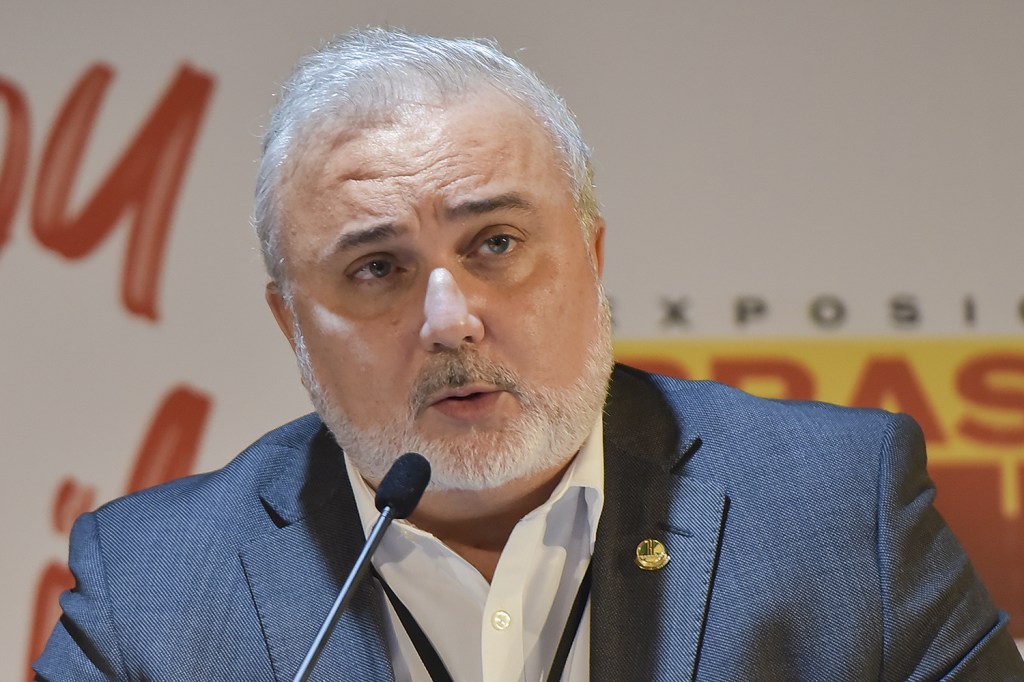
[268,91,610,489]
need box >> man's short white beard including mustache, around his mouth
[293,290,613,491]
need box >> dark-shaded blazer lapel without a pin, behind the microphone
[240,428,394,680]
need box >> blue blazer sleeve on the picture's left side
[33,513,128,682]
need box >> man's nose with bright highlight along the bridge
[420,267,483,351]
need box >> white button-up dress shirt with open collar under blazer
[345,419,604,682]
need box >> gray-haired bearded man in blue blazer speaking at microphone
[36,30,1024,681]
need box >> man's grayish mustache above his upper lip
[410,348,522,415]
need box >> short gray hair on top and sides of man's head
[253,29,600,282]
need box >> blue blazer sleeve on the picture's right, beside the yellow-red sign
[878,415,1024,682]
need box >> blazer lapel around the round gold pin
[591,367,728,682]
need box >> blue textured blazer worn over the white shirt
[36,367,1024,682]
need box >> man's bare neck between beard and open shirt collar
[410,458,572,583]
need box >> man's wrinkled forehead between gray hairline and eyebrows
[289,93,571,268]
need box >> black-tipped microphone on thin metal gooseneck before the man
[293,453,430,682]
